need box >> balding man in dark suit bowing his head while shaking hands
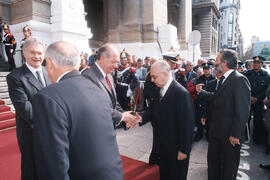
[142,61,194,180]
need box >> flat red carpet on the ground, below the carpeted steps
[0,128,159,180]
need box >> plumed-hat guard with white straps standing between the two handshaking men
[115,50,139,110]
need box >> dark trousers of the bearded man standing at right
[207,137,241,180]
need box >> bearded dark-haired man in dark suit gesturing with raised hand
[196,49,251,180]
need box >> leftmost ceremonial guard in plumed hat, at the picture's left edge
[2,23,17,71]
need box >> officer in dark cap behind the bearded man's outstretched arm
[194,63,216,141]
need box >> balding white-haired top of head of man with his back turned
[45,41,80,69]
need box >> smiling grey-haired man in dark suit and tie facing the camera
[7,38,50,180]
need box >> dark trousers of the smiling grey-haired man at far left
[17,127,38,180]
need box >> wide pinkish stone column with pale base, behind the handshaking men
[105,0,167,58]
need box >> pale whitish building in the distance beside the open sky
[218,0,243,57]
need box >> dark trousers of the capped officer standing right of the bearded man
[251,101,267,144]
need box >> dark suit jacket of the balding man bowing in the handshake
[142,80,195,156]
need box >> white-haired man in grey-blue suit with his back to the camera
[33,41,123,180]
